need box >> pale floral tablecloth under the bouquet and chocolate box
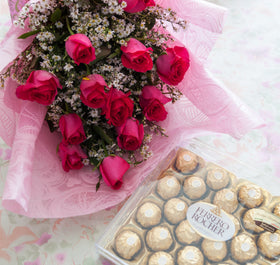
[0,0,280,265]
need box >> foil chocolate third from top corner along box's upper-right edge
[238,184,264,208]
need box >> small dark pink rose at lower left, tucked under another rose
[58,142,87,172]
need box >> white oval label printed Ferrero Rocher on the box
[187,202,235,241]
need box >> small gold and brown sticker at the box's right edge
[253,209,280,233]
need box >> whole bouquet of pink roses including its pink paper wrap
[0,0,256,217]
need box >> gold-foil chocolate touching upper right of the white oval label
[213,189,238,213]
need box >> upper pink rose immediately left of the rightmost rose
[121,38,153,73]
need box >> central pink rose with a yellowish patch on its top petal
[80,74,107,108]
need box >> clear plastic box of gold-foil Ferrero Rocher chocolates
[97,139,280,265]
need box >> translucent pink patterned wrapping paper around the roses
[0,0,260,218]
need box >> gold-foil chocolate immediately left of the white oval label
[163,198,188,224]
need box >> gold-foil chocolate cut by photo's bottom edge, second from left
[177,246,204,265]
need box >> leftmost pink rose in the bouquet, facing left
[16,70,62,106]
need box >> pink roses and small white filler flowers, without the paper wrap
[2,0,189,189]
